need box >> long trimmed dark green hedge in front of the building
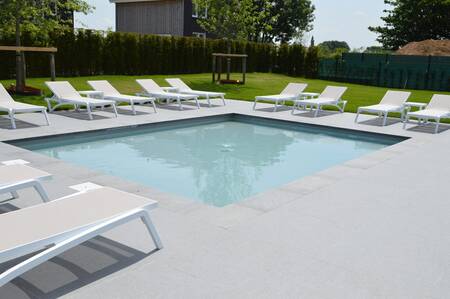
[0,30,319,79]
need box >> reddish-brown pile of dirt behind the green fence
[396,39,450,56]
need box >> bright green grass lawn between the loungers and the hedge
[0,73,450,112]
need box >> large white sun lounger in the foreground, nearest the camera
[0,187,163,287]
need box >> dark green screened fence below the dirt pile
[319,53,450,91]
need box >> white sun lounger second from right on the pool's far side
[355,90,411,126]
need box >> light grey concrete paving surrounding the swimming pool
[0,100,450,299]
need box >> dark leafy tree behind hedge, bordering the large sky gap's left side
[250,0,315,43]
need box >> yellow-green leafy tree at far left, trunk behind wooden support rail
[0,0,90,92]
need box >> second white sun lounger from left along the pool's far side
[45,81,117,120]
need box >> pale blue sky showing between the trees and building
[75,0,386,48]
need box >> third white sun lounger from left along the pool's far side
[88,80,156,115]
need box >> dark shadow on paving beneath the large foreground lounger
[0,236,157,299]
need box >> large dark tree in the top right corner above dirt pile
[369,0,450,50]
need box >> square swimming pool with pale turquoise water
[10,114,404,207]
